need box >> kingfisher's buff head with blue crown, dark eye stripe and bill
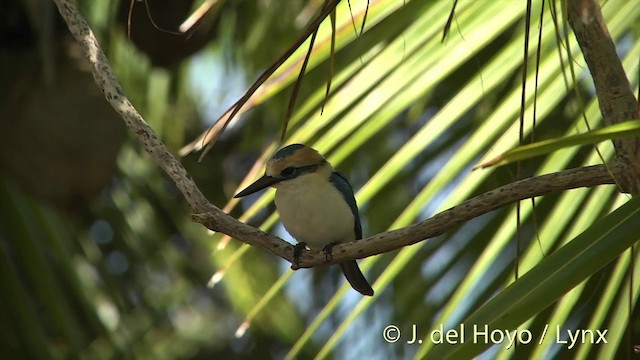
[234,144,333,198]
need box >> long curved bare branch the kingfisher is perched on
[54,0,625,268]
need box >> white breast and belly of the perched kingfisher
[275,174,355,250]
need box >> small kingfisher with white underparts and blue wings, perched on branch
[234,144,373,296]
